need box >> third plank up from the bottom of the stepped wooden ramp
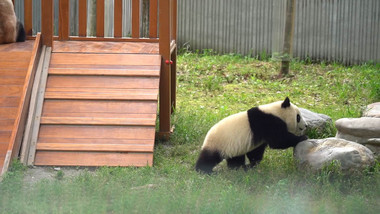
[39,125,155,140]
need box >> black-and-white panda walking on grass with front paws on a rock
[195,97,307,174]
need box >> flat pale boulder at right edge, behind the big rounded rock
[335,117,380,156]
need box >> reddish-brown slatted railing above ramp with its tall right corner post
[16,0,177,138]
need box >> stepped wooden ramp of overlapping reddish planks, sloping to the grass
[29,41,161,166]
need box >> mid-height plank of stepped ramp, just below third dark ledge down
[42,100,157,116]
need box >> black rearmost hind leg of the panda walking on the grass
[195,149,223,174]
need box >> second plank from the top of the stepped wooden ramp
[50,53,161,65]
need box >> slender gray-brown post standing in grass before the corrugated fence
[280,0,295,76]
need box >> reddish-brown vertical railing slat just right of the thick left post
[58,0,70,40]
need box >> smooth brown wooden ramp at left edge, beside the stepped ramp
[0,37,40,175]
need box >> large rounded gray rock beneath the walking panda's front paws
[294,138,375,171]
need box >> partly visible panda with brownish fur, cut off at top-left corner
[0,0,26,44]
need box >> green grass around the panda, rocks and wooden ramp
[0,51,380,213]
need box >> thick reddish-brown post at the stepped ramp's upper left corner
[41,0,54,47]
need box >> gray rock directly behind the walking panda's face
[300,108,332,131]
